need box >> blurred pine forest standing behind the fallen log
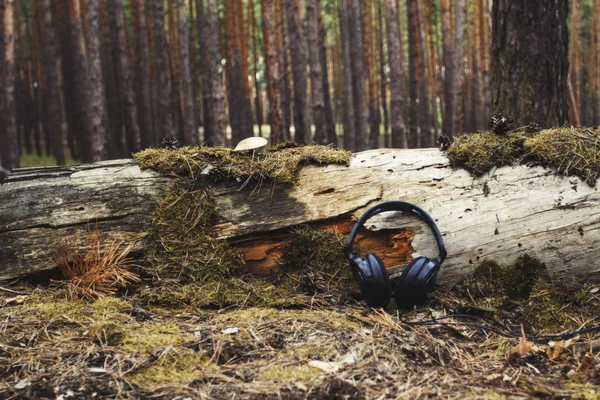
[0,0,600,169]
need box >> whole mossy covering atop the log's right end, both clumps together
[448,128,600,186]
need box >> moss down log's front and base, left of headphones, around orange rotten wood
[136,187,356,309]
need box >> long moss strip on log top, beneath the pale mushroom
[133,144,352,183]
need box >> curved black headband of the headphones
[344,200,446,264]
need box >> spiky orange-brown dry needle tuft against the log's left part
[54,231,140,298]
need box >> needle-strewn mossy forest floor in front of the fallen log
[0,270,600,399]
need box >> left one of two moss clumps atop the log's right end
[448,131,523,176]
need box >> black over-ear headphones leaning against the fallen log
[344,201,446,308]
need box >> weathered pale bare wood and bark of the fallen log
[0,149,600,285]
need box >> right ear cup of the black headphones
[394,257,440,308]
